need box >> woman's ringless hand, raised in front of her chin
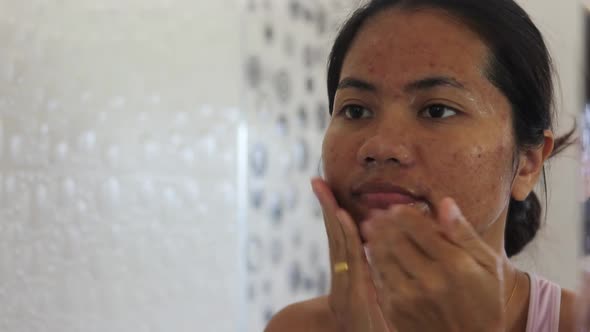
[361,199,505,332]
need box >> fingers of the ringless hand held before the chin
[361,201,501,296]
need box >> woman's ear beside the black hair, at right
[512,130,555,201]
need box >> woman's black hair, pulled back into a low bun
[327,0,575,257]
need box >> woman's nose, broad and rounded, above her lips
[357,129,414,167]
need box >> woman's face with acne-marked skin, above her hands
[322,9,515,239]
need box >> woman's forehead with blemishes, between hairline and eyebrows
[341,10,488,89]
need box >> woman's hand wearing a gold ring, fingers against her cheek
[312,178,393,332]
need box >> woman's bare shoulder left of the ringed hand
[264,296,336,332]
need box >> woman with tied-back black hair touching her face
[267,0,574,332]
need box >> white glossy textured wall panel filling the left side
[0,0,243,332]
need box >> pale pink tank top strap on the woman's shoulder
[526,274,561,332]
